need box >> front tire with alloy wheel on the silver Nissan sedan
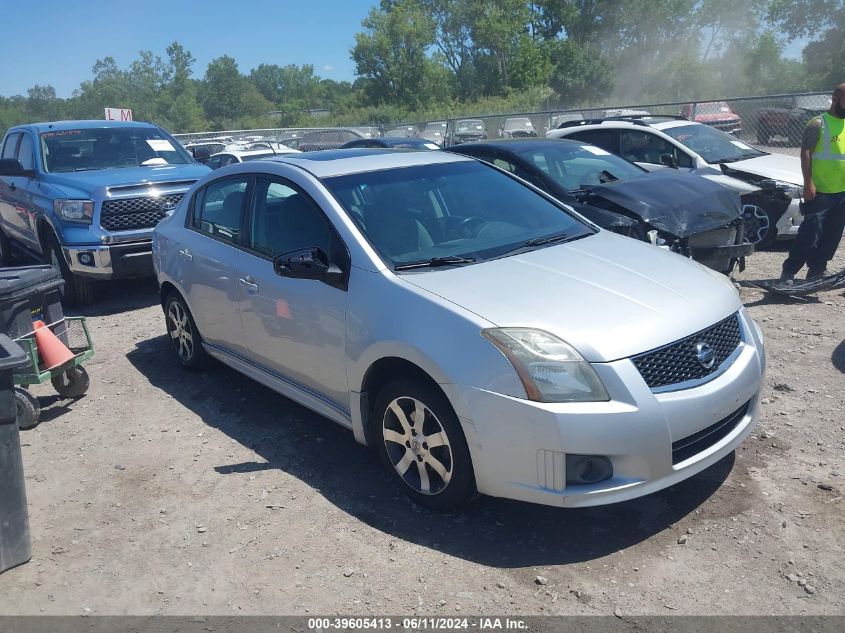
[372,380,475,511]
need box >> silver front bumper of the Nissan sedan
[444,311,765,507]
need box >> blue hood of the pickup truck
[45,164,211,194]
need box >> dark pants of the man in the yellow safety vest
[783,192,845,275]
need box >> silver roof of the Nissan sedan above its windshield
[262,147,471,178]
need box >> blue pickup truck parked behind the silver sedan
[0,121,210,305]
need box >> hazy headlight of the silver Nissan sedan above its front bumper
[481,328,610,402]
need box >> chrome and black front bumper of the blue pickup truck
[62,240,154,280]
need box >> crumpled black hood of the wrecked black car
[585,169,742,237]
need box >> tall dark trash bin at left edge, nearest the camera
[0,334,32,573]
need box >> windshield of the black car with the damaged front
[518,141,647,192]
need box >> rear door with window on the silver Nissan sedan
[178,174,252,355]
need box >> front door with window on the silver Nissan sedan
[238,176,349,411]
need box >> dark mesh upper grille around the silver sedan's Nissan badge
[631,314,742,389]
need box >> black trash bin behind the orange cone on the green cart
[0,265,67,345]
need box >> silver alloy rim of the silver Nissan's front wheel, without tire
[382,397,453,495]
